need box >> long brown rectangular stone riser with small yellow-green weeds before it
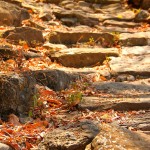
[49,30,114,46]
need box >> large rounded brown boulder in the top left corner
[0,1,30,26]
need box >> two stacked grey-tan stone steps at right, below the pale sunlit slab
[86,78,150,111]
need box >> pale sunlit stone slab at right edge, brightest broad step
[109,54,150,76]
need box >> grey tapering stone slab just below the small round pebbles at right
[93,78,150,95]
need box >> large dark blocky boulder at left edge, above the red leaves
[0,73,36,115]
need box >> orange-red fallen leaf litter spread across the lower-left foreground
[0,79,145,150]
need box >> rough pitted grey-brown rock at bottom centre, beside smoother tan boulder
[38,120,99,150]
